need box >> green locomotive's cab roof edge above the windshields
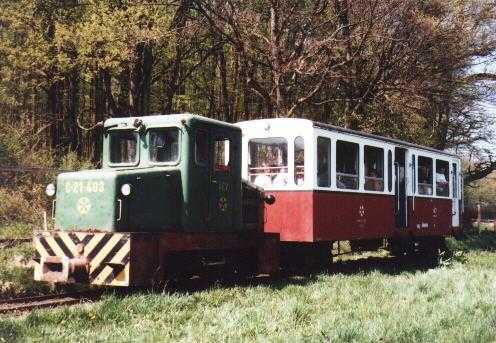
[104,113,239,130]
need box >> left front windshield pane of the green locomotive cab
[110,131,138,164]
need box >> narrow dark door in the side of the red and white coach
[394,148,408,228]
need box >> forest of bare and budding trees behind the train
[0,0,496,177]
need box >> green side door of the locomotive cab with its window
[209,130,235,230]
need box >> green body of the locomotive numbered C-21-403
[56,114,243,232]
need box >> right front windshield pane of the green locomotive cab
[149,128,179,163]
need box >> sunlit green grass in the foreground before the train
[0,232,496,342]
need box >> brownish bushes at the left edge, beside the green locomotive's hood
[0,116,92,226]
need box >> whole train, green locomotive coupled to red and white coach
[34,113,463,287]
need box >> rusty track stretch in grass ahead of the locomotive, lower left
[0,291,102,314]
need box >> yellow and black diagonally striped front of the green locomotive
[34,231,131,286]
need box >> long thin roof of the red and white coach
[238,118,458,158]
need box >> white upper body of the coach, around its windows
[236,118,461,198]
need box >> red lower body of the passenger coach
[264,191,452,242]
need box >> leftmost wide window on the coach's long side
[336,141,360,189]
